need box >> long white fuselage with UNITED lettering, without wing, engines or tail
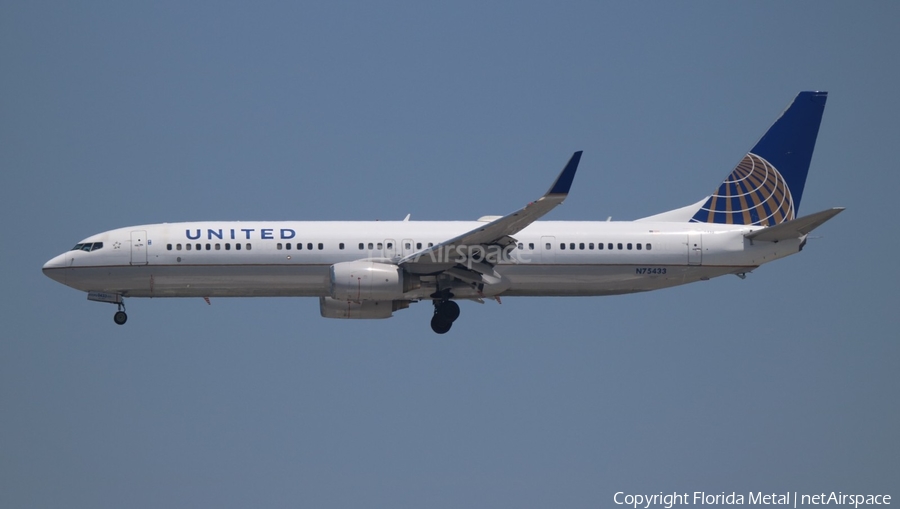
[44,221,803,301]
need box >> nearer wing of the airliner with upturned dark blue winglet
[398,151,581,274]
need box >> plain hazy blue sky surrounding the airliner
[0,2,900,508]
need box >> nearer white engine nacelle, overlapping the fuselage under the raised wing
[329,261,421,302]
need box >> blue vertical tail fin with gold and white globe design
[691,92,828,226]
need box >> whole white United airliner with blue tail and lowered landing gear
[43,91,844,334]
